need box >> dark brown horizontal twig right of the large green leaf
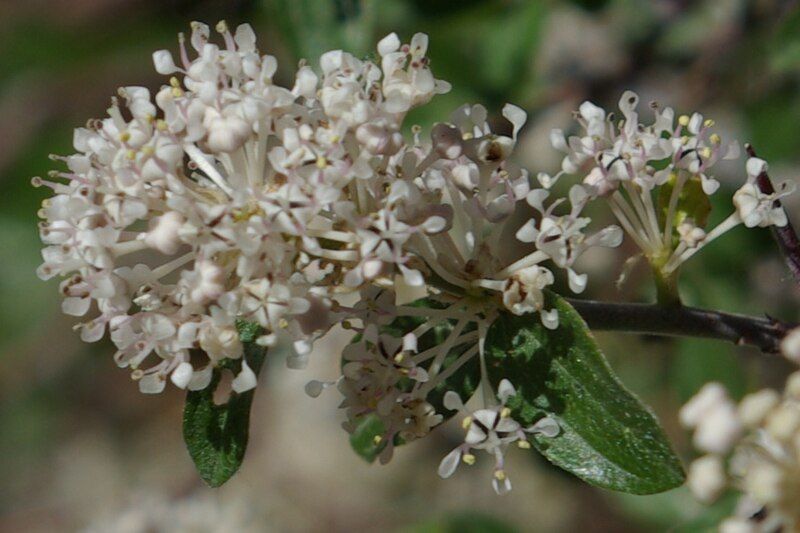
[568,299,797,353]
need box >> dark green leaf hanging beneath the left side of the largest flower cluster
[183,322,266,487]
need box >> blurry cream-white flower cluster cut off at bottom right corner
[680,372,800,533]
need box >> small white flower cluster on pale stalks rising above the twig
[538,91,791,275]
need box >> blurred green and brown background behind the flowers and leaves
[0,0,800,532]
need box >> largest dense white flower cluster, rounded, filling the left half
[33,22,619,402]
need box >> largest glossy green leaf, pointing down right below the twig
[486,293,685,494]
